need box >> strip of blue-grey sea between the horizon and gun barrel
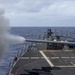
[11,27,75,38]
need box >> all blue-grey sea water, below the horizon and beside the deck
[0,27,75,75]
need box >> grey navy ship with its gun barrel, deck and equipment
[9,29,75,75]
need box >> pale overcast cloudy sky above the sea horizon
[0,0,75,27]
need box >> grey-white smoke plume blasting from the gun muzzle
[0,9,25,59]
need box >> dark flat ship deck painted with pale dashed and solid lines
[11,50,75,75]
